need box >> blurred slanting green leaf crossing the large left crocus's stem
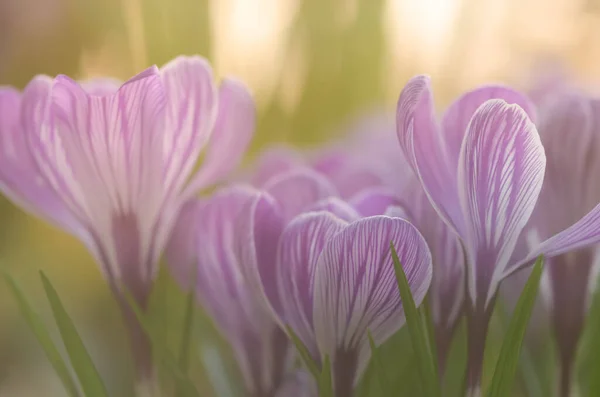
[123,289,199,397]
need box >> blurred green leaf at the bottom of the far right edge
[582,268,600,396]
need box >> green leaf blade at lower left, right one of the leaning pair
[40,271,108,397]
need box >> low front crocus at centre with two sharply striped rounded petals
[240,193,431,397]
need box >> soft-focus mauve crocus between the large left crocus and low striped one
[167,186,311,397]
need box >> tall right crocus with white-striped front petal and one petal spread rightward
[397,76,600,396]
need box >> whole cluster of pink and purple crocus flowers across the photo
[0,51,600,397]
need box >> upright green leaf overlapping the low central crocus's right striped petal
[390,242,441,397]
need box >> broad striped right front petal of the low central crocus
[313,216,432,383]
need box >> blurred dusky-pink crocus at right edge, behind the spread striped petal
[533,91,600,396]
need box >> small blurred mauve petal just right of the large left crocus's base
[165,199,206,291]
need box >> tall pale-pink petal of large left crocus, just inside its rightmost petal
[160,57,219,199]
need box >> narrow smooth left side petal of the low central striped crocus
[236,192,285,320]
